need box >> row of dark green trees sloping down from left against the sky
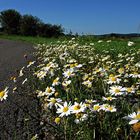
[0,9,64,37]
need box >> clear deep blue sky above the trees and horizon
[0,0,140,34]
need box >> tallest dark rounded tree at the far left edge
[0,9,21,34]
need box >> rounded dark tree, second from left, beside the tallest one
[20,15,41,36]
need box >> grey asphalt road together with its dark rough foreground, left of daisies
[0,39,39,140]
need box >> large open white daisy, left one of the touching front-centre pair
[56,101,71,117]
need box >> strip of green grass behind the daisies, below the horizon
[0,34,140,55]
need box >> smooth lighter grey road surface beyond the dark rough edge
[0,39,34,87]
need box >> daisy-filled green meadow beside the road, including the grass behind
[0,36,140,140]
